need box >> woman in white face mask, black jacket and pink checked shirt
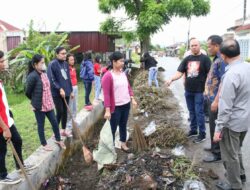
[25,54,66,151]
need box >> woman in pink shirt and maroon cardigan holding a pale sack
[102,51,137,152]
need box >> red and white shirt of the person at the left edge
[0,80,14,133]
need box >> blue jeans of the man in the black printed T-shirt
[185,91,206,135]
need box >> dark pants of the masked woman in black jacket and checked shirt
[34,110,61,146]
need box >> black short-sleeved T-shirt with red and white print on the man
[178,54,211,93]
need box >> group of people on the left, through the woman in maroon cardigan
[0,47,137,184]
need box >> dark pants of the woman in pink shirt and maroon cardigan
[110,102,130,142]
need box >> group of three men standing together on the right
[166,35,250,190]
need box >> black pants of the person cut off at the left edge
[0,125,23,179]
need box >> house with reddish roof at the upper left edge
[0,20,24,52]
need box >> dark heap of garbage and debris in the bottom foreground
[96,151,199,189]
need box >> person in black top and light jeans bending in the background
[141,52,159,87]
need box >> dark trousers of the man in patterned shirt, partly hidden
[208,101,221,157]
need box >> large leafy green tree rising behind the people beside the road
[99,0,210,52]
